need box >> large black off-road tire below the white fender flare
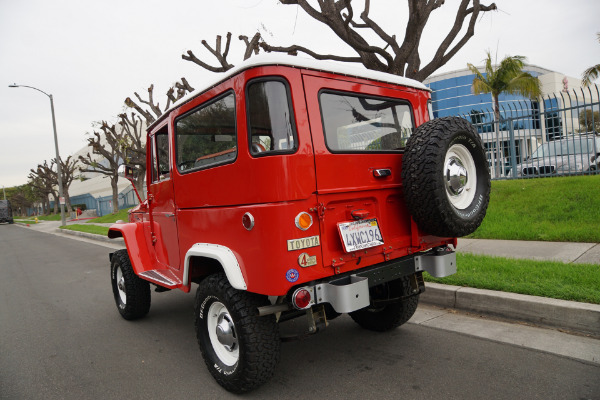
[195,273,281,393]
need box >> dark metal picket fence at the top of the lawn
[460,85,600,179]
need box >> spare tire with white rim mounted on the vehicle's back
[402,117,490,237]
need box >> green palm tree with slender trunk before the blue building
[467,51,542,177]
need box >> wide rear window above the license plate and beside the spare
[319,92,414,152]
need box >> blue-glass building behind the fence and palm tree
[423,65,581,178]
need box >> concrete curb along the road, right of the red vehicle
[421,282,600,336]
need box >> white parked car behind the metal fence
[517,135,600,178]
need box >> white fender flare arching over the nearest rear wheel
[183,243,248,290]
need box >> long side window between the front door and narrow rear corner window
[175,93,237,172]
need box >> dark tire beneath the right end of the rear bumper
[350,278,419,332]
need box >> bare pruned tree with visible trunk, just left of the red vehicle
[79,121,125,213]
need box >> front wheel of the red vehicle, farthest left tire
[110,250,150,320]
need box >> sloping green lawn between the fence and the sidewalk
[468,175,600,243]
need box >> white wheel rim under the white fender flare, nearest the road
[206,301,240,367]
